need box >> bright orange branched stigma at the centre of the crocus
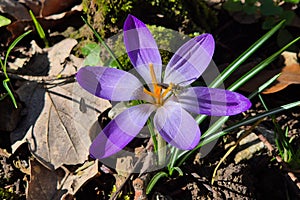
[143,63,173,105]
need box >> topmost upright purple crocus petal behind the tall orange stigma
[123,15,162,83]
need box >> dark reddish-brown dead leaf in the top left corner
[0,0,82,44]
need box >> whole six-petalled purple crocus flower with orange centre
[76,15,251,159]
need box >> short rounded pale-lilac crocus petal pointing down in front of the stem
[154,101,200,150]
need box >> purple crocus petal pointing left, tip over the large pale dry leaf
[76,67,149,101]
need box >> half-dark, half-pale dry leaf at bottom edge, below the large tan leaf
[26,160,100,200]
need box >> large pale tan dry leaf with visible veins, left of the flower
[11,40,110,169]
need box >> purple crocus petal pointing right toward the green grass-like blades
[178,87,251,116]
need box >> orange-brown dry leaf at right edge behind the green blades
[263,52,300,94]
